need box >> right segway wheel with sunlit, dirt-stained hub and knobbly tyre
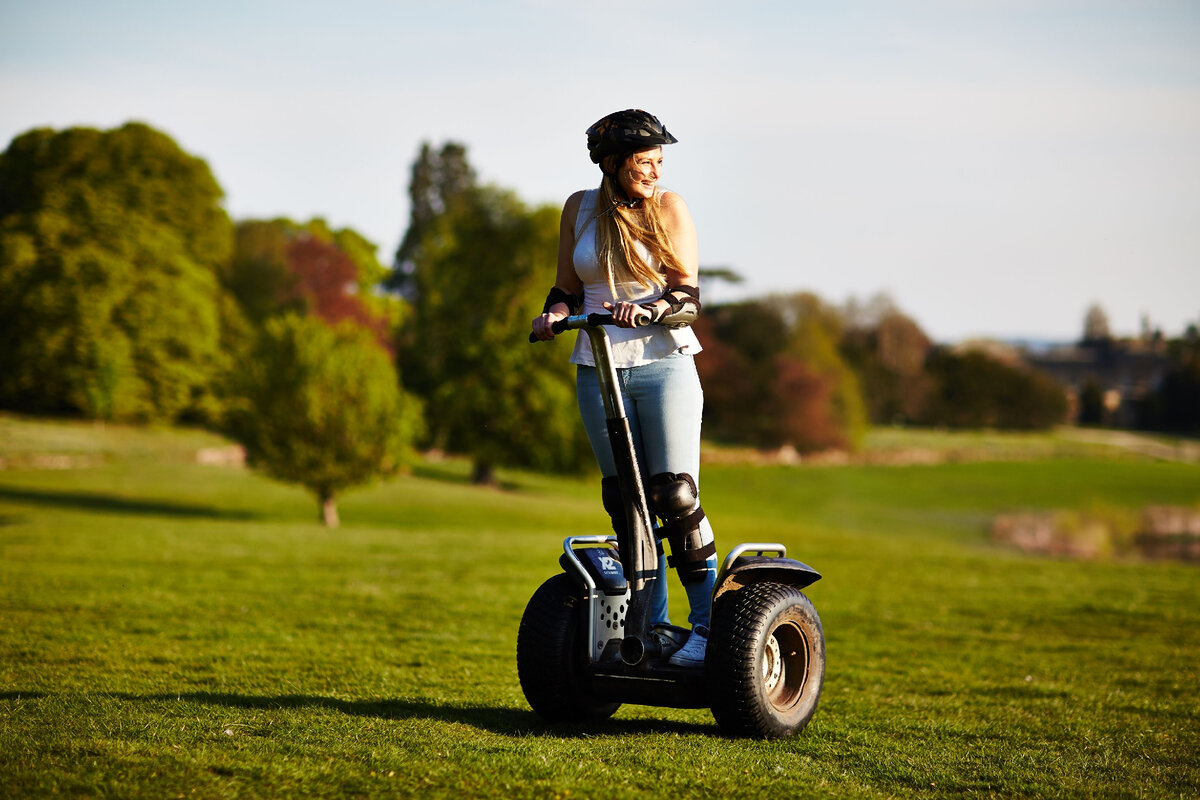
[704,582,824,739]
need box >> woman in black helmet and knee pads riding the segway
[533,109,716,667]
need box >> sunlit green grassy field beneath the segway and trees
[0,416,1200,798]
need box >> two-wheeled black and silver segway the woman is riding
[517,314,824,739]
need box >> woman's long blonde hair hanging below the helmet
[593,154,688,296]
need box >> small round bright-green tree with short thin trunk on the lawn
[229,314,419,527]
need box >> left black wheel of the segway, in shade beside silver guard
[517,573,620,722]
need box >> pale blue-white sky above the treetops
[0,0,1200,342]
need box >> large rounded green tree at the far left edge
[0,122,233,420]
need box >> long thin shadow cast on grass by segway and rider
[126,692,719,739]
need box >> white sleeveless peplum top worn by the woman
[571,188,702,367]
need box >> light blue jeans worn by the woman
[575,353,716,627]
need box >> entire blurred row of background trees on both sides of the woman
[0,124,1200,524]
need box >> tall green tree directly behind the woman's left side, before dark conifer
[402,186,590,483]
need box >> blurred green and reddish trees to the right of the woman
[697,293,1067,452]
